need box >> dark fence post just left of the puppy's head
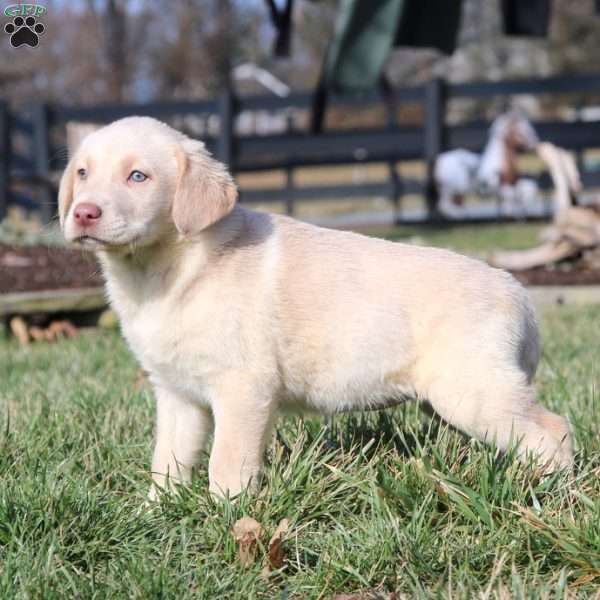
[32,103,57,223]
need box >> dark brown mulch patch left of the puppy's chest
[0,244,103,294]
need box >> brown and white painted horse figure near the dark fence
[434,111,539,216]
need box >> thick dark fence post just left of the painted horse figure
[425,77,446,220]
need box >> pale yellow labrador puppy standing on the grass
[59,117,572,495]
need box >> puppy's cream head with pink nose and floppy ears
[58,117,237,250]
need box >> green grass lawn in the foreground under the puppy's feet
[0,307,600,599]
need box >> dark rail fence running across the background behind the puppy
[0,74,600,221]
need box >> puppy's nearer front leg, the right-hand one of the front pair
[208,374,276,497]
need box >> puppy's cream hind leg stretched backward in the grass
[429,371,573,470]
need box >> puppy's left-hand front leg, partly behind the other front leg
[150,387,212,500]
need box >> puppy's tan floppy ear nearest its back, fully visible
[172,138,237,235]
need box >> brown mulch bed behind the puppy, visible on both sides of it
[0,244,600,294]
